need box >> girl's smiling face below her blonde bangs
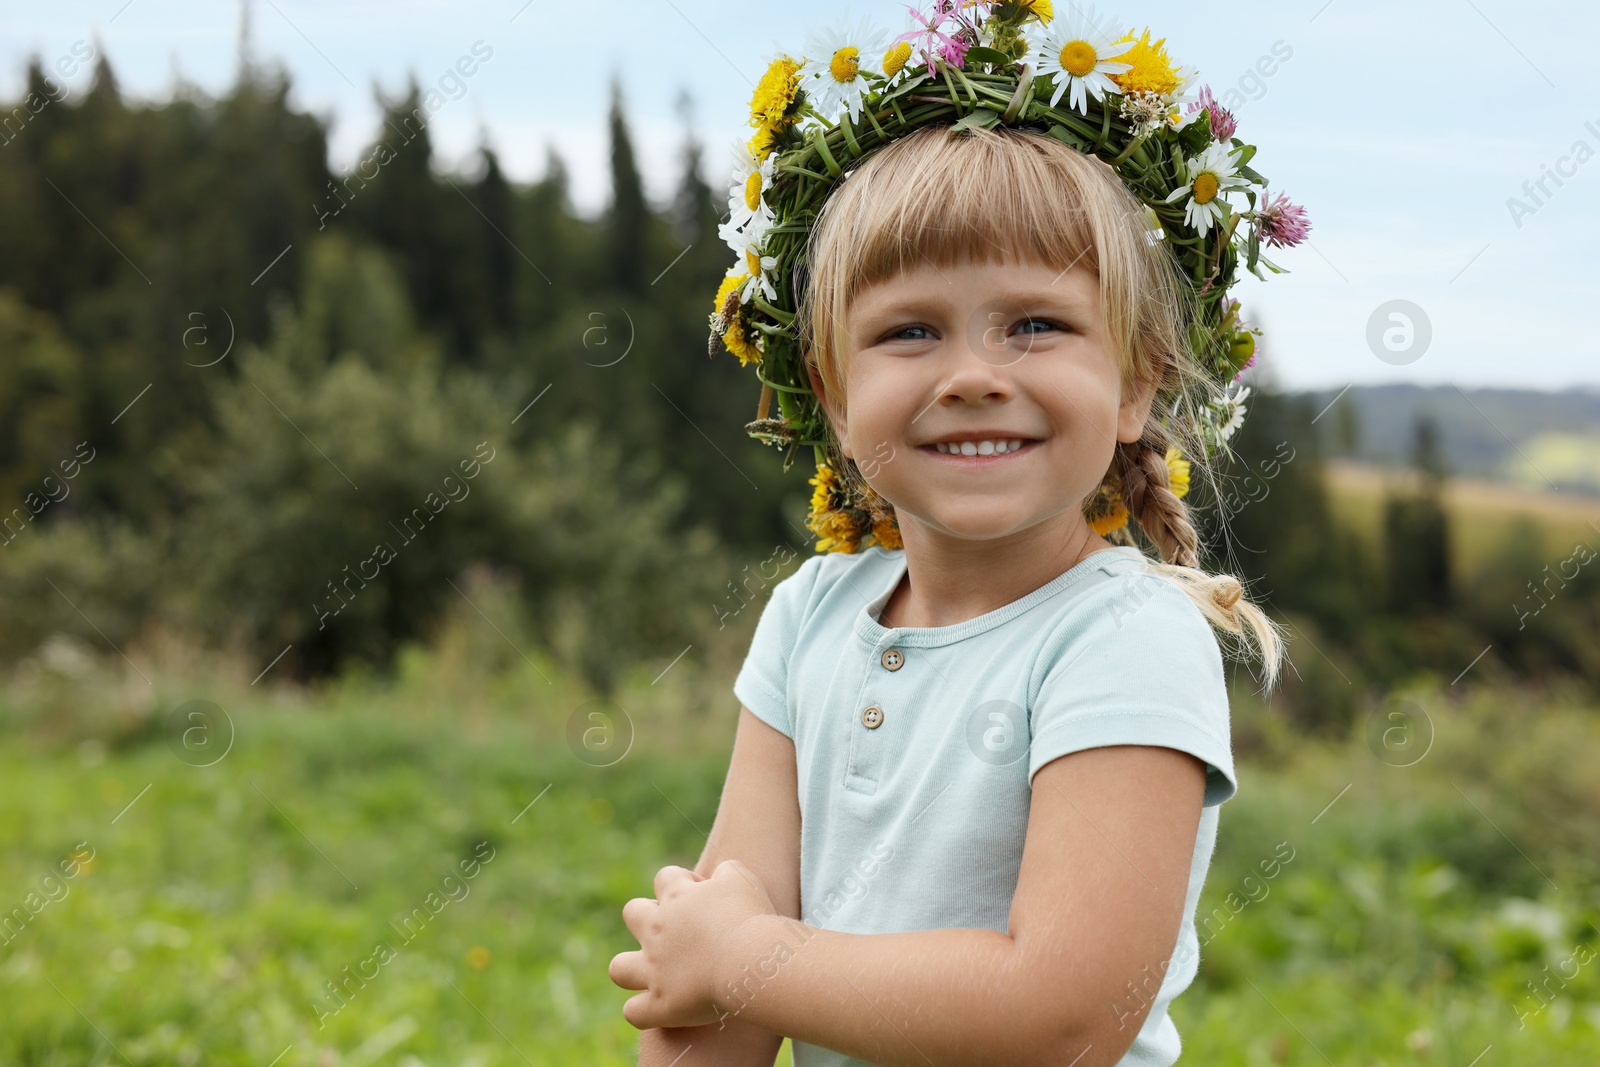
[813,254,1154,545]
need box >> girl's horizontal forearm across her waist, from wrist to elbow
[717,915,1083,1067]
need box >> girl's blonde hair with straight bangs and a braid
[797,126,1283,688]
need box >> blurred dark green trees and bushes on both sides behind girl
[0,58,1600,720]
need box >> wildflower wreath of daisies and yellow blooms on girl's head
[709,0,1310,552]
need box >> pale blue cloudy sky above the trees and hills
[0,0,1600,390]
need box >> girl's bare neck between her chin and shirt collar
[878,518,1115,629]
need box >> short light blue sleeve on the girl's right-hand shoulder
[1027,571,1238,808]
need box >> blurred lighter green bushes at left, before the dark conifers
[0,238,722,688]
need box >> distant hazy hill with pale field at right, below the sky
[1285,386,1600,496]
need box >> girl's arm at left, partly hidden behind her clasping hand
[638,707,800,1067]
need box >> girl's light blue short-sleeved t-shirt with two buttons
[733,547,1238,1067]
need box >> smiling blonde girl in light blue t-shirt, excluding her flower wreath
[610,6,1282,1067]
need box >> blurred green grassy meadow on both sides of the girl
[0,614,1600,1067]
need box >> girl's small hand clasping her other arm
[608,859,778,1030]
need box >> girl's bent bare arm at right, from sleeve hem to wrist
[715,745,1205,1067]
